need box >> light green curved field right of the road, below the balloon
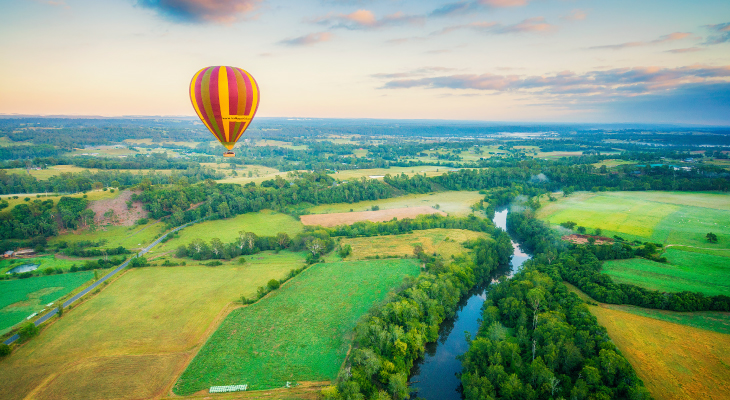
[153,210,304,254]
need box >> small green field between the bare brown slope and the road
[49,221,165,249]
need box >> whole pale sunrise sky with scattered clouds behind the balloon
[0,0,730,125]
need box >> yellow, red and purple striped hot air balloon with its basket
[190,67,260,157]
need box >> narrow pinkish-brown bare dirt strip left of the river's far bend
[301,206,446,228]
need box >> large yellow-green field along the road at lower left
[0,252,304,400]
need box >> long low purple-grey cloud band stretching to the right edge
[374,65,730,101]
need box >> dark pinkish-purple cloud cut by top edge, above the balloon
[137,0,262,24]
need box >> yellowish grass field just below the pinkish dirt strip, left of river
[340,229,487,260]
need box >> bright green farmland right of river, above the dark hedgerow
[538,191,730,295]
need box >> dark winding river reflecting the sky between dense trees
[409,209,530,400]
